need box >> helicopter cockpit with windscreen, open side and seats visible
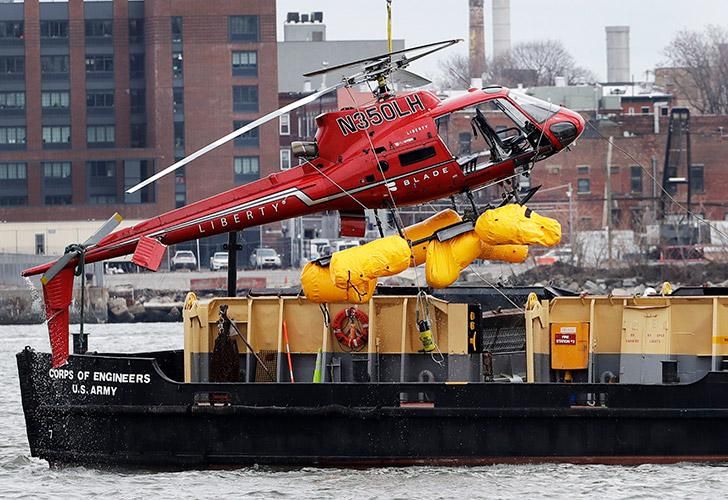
[437,92,559,175]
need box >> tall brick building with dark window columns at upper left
[0,0,279,264]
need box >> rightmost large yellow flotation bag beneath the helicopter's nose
[475,204,561,247]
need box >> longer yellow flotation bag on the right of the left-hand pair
[329,236,410,289]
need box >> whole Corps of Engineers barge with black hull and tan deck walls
[17,287,728,467]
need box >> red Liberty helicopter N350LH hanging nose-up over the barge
[23,40,584,366]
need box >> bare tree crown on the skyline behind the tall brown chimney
[439,40,596,89]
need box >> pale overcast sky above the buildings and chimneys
[276,0,728,81]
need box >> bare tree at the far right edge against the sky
[665,26,728,114]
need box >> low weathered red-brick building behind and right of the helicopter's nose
[432,93,728,244]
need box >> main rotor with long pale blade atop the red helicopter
[126,39,462,194]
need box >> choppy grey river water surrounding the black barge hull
[0,323,728,500]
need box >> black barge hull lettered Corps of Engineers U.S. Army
[17,348,728,467]
